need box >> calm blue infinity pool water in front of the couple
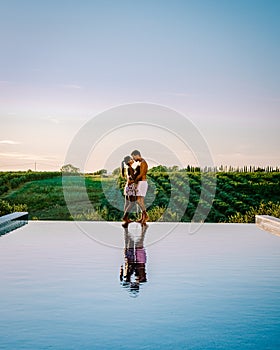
[0,222,280,350]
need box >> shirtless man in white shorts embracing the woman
[131,150,148,225]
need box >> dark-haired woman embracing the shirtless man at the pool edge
[121,156,139,227]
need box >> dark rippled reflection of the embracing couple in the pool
[120,225,148,296]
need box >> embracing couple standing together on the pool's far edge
[122,150,148,227]
